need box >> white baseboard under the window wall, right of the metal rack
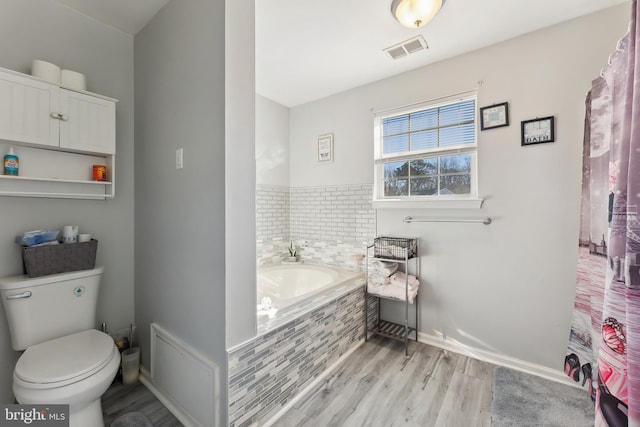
[418,332,580,388]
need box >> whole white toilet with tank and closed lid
[0,267,120,427]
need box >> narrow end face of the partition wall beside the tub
[224,0,257,348]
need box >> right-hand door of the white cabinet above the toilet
[60,89,116,154]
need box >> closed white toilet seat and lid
[14,329,118,388]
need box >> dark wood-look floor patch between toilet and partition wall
[102,382,182,427]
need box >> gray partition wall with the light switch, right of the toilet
[135,0,228,425]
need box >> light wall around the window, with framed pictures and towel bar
[290,5,630,369]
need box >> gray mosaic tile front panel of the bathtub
[228,287,364,427]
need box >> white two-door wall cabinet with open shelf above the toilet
[0,69,117,199]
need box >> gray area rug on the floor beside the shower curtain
[491,366,594,427]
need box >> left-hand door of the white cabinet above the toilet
[0,72,60,147]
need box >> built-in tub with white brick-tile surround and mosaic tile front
[245,184,377,427]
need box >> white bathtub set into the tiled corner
[256,264,364,329]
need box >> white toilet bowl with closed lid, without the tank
[13,329,120,427]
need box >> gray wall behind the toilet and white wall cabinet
[0,0,134,403]
